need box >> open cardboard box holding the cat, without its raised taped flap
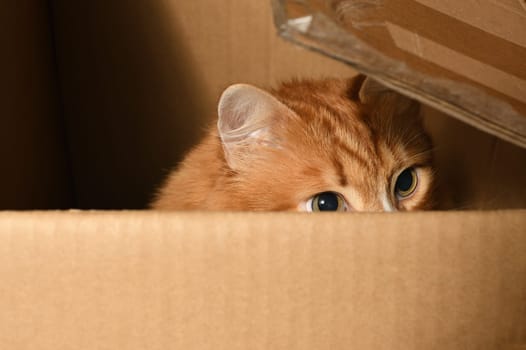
[0,0,526,350]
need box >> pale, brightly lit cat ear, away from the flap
[217,84,291,169]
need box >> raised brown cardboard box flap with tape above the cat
[273,0,526,147]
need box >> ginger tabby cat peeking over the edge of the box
[152,75,435,212]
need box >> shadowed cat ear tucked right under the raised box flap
[358,77,419,115]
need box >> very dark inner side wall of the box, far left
[0,0,73,209]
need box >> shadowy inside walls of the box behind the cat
[0,0,526,209]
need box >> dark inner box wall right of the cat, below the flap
[423,107,526,210]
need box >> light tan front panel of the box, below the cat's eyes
[0,210,526,350]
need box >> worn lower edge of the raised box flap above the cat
[272,0,526,148]
